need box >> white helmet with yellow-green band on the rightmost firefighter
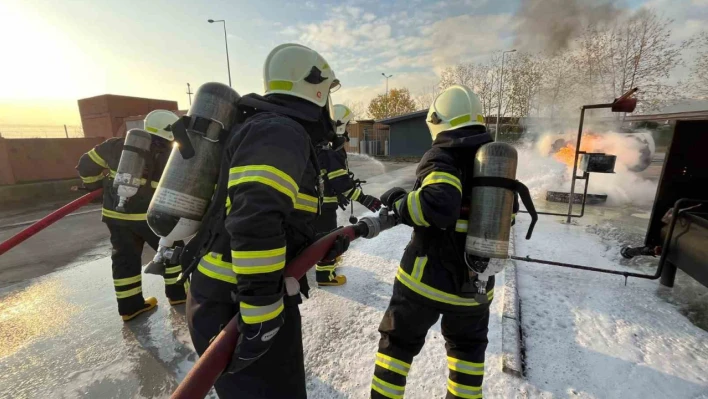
[425,85,484,140]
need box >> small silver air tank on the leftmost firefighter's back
[113,129,152,212]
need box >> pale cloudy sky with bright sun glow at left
[0,0,708,125]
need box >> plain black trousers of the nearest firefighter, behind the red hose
[187,289,307,399]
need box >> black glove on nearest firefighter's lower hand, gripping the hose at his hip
[225,313,285,373]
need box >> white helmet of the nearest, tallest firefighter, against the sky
[263,43,339,107]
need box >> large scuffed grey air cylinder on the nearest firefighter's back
[147,82,240,246]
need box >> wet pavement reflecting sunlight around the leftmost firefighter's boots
[0,156,414,399]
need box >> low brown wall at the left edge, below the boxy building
[0,137,104,185]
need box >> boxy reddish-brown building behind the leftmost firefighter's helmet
[78,94,177,137]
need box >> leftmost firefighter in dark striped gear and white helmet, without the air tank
[76,110,187,321]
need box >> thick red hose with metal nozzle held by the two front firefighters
[171,210,397,399]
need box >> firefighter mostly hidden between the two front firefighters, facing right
[315,104,381,286]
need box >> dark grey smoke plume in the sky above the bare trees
[514,0,622,54]
